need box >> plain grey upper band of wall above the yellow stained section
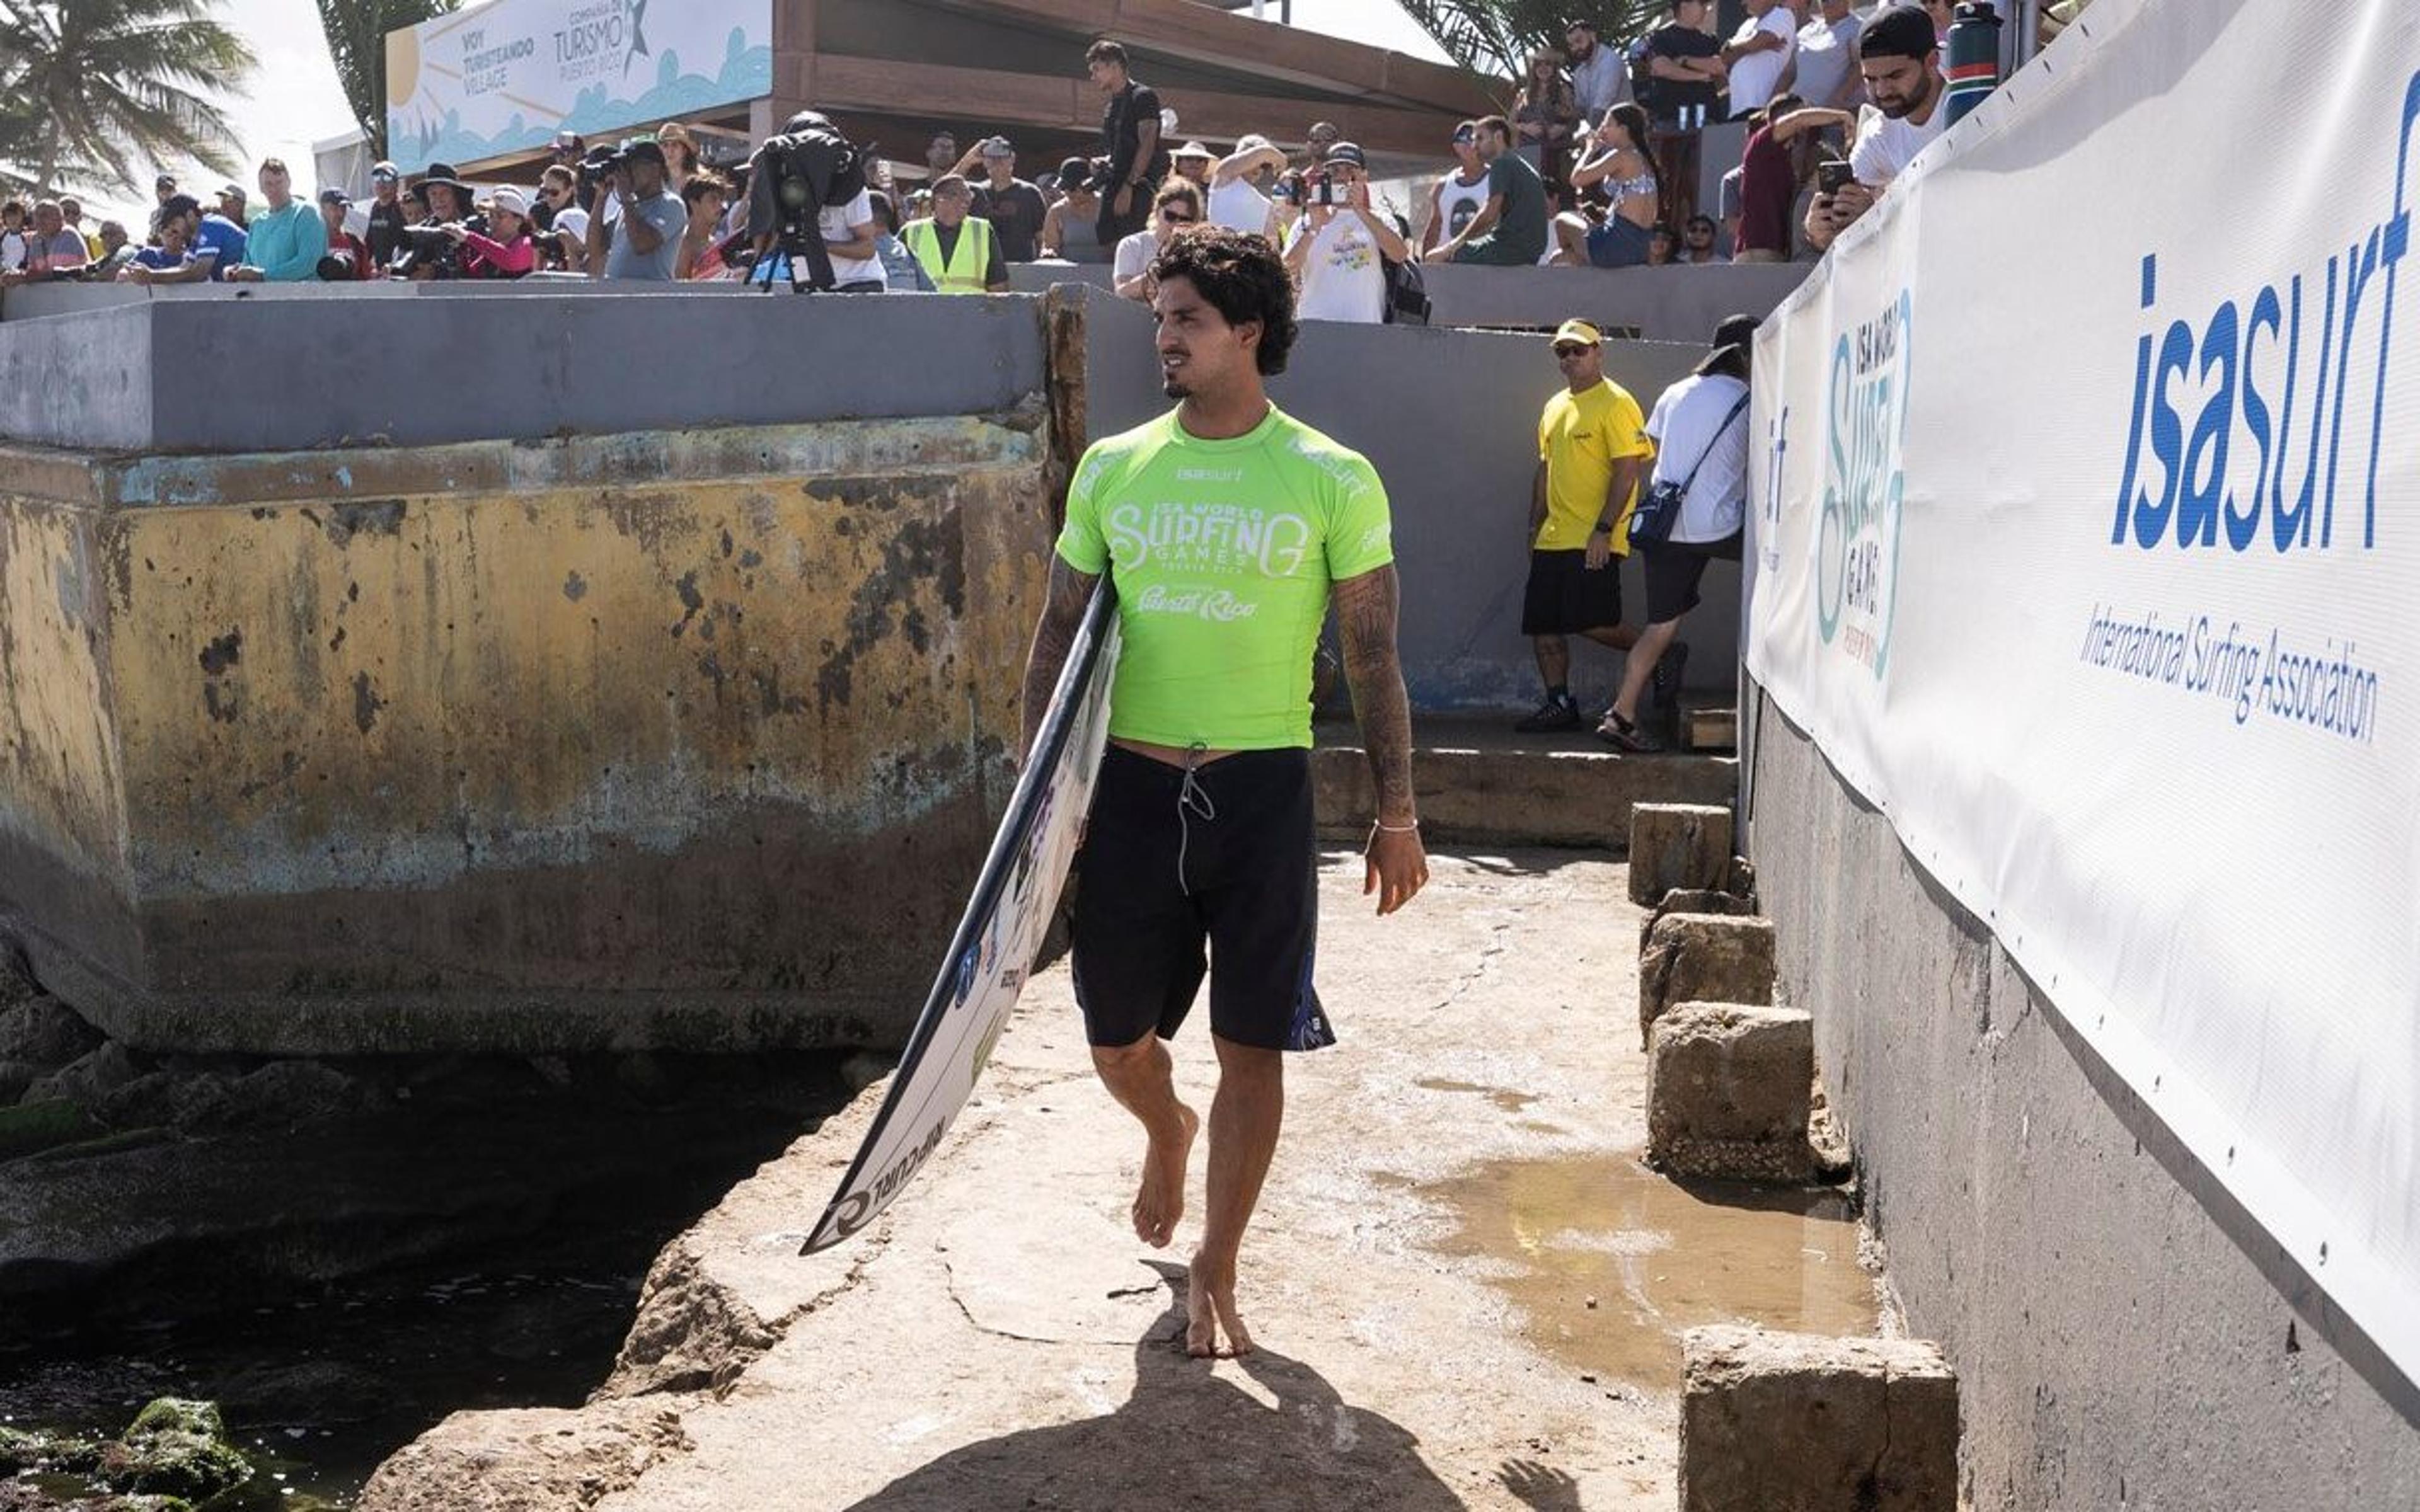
[0,280,1043,452]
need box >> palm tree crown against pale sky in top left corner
[0,0,251,193]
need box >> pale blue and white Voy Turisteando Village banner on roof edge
[387,0,772,174]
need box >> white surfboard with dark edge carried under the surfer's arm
[798,578,1118,1256]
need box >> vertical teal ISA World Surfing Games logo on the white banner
[1815,288,1914,677]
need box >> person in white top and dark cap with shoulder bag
[1597,314,1757,750]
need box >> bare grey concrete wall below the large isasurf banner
[1752,706,2420,1512]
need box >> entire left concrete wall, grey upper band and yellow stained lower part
[0,290,1063,1052]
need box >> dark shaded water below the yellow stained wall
[0,1060,847,1512]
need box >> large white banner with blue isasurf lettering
[1747,0,2420,1379]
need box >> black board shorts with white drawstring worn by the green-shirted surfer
[1075,745,1336,1050]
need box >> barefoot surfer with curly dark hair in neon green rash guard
[1023,227,1428,1357]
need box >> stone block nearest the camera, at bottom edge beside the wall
[1680,1326,1958,1512]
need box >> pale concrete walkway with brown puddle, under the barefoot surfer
[372,852,1876,1512]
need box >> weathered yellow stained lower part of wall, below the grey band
[0,416,1052,1052]
